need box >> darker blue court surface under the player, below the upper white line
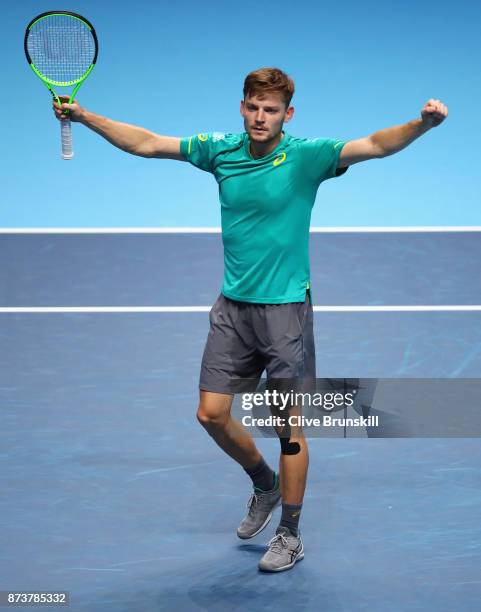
[0,232,481,612]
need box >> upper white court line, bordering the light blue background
[0,225,481,235]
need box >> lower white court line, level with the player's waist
[0,304,481,314]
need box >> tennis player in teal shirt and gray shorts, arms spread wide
[54,68,448,572]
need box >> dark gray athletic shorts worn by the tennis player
[199,290,316,394]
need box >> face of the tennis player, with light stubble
[240,93,294,143]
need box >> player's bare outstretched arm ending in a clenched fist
[337,99,448,168]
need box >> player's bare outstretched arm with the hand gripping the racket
[53,96,186,161]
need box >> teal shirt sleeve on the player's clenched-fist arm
[303,138,347,184]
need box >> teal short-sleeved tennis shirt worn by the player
[180,132,347,304]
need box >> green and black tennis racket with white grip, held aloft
[24,11,98,159]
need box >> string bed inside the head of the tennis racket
[27,15,96,84]
